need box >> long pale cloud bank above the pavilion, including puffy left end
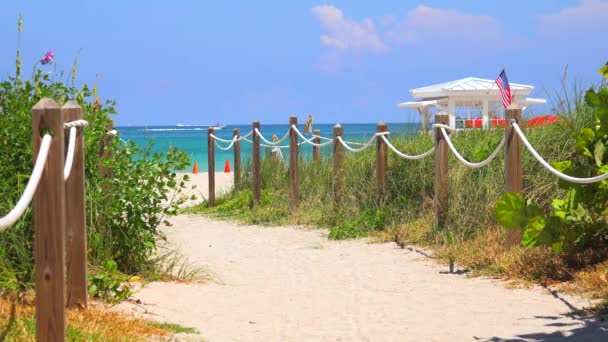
[312,5,523,52]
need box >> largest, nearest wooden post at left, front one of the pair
[32,98,65,341]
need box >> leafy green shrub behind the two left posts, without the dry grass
[0,19,188,290]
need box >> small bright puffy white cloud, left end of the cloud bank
[312,5,385,52]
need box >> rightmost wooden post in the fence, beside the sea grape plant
[505,104,522,250]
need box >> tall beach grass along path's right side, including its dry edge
[188,88,608,298]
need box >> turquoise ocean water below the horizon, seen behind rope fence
[116,123,420,172]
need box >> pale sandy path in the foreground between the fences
[115,216,608,341]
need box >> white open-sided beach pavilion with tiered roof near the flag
[398,77,547,130]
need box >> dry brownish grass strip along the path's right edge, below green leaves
[390,219,608,299]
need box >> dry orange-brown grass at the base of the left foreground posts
[0,296,171,341]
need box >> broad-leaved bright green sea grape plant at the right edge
[494,63,608,253]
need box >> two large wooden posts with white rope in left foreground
[0,98,100,341]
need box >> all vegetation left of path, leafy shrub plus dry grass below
[0,18,193,341]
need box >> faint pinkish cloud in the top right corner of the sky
[539,0,608,37]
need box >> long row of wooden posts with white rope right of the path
[209,106,608,248]
